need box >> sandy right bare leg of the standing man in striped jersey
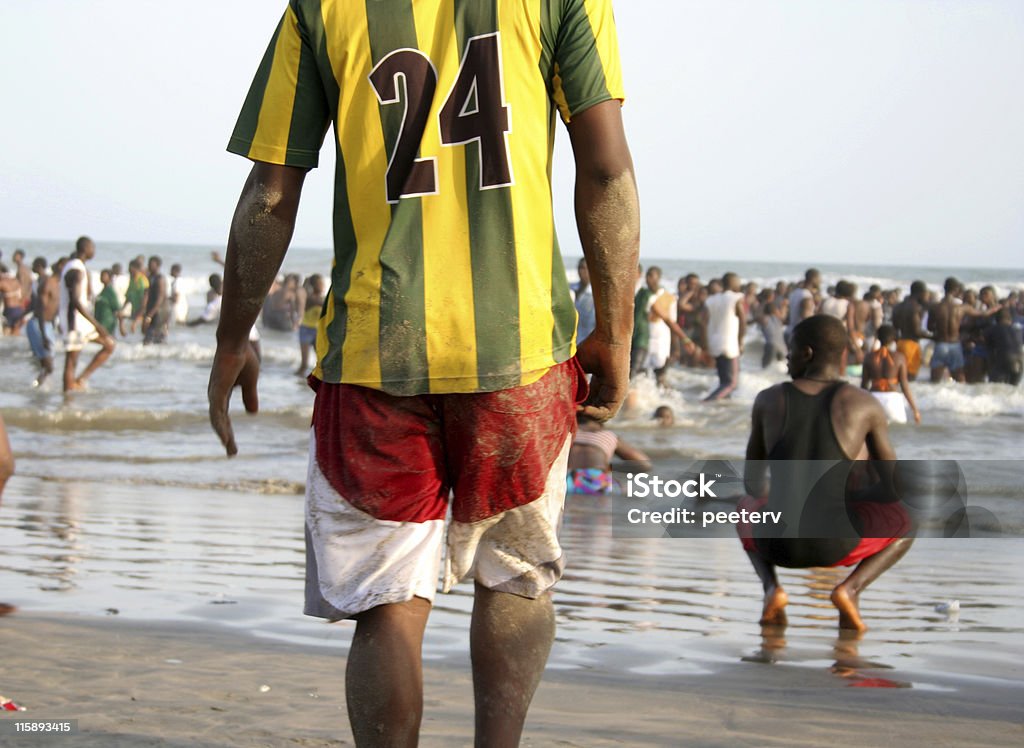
[469,584,555,748]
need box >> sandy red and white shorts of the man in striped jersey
[305,359,587,620]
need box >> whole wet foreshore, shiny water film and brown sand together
[0,477,1024,746]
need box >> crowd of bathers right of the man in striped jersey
[589,260,1024,421]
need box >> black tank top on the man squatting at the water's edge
[754,382,859,569]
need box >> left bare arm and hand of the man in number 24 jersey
[207,162,306,456]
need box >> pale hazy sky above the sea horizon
[0,0,1024,267]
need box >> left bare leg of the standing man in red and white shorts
[345,597,430,748]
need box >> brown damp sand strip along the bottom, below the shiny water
[0,612,1024,748]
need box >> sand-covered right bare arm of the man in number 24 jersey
[568,100,640,421]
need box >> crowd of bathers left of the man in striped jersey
[0,237,327,391]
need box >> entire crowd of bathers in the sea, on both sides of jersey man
[0,237,1024,405]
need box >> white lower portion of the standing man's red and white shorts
[305,430,572,621]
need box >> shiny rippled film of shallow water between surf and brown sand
[0,477,1024,688]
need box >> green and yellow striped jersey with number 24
[228,0,623,394]
